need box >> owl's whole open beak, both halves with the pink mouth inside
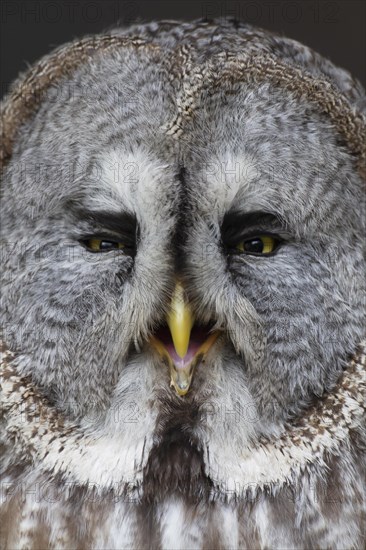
[151,281,219,395]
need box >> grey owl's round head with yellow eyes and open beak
[1,21,365,496]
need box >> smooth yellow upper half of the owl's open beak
[167,281,194,358]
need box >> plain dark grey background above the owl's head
[0,0,366,99]
